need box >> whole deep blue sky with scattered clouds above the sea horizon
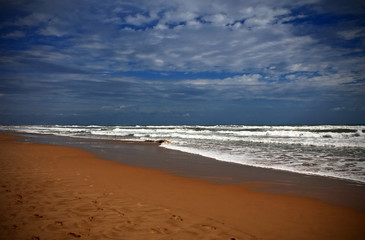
[0,0,365,125]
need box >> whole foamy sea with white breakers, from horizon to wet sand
[0,125,365,183]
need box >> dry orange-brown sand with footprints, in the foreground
[0,135,365,239]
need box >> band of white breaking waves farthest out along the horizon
[0,125,365,147]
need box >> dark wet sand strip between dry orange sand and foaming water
[9,130,365,211]
